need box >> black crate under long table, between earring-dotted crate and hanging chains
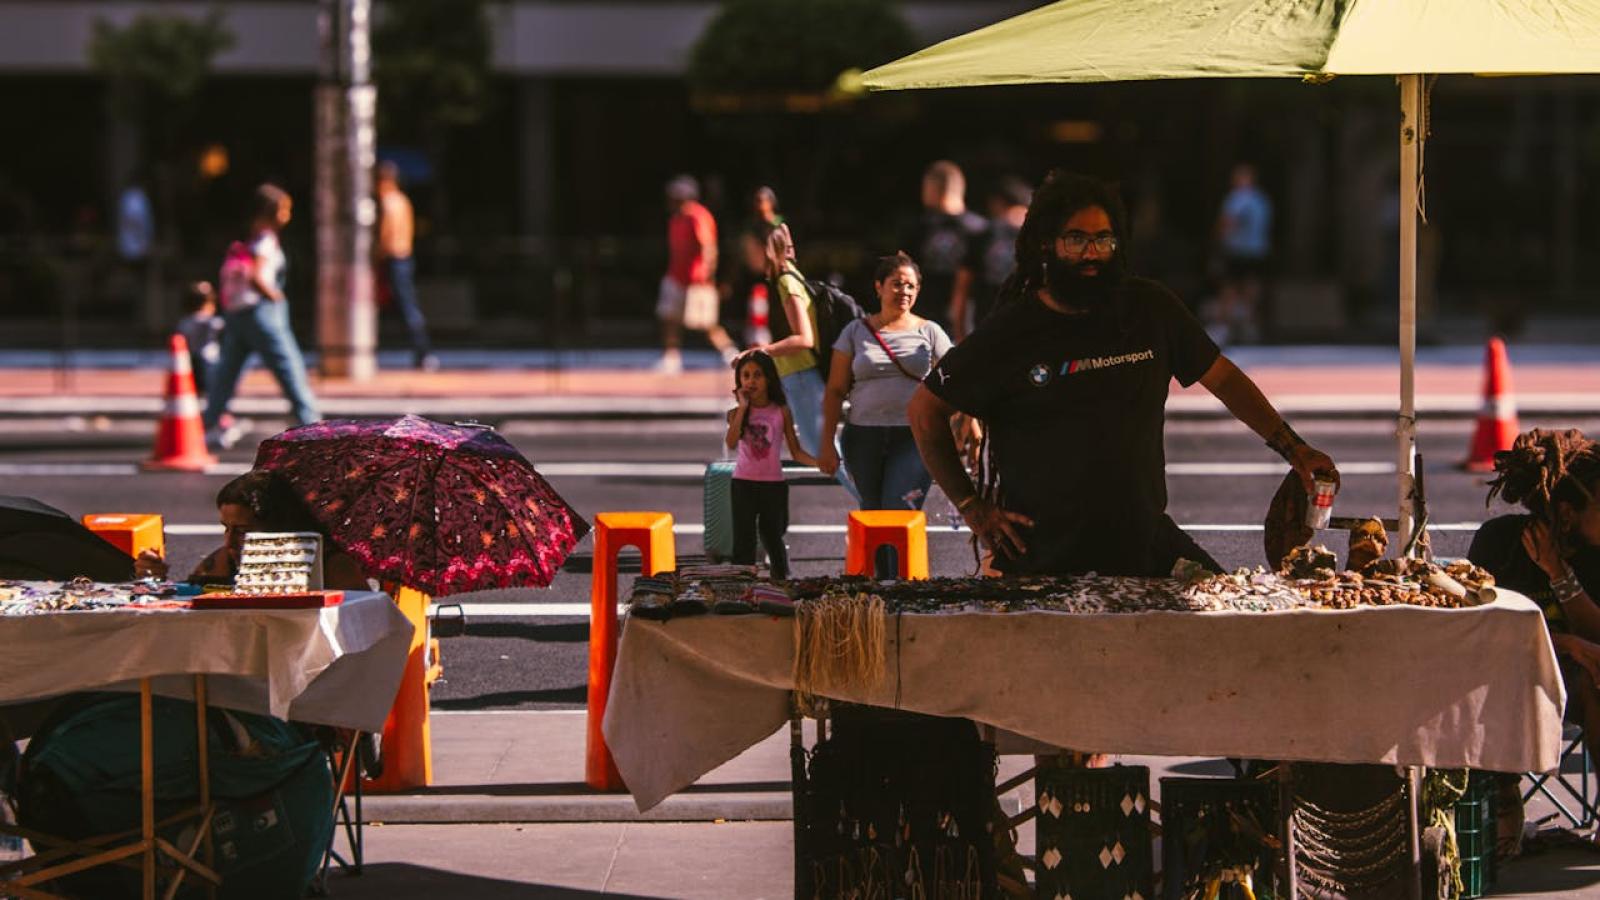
[1162,778,1283,900]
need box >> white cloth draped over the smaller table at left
[0,593,411,737]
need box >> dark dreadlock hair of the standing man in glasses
[995,168,1128,312]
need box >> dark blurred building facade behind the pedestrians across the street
[0,0,1600,344]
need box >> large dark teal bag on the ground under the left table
[16,693,334,900]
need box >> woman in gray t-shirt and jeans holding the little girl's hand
[818,253,950,578]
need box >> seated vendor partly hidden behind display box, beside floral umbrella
[133,469,370,591]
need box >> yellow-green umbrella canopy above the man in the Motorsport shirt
[864,0,1600,90]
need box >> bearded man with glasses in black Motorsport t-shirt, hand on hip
[909,171,1338,577]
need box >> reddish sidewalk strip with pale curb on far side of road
[9,344,1600,421]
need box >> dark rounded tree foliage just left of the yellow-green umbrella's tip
[688,0,917,93]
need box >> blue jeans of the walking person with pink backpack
[205,299,322,428]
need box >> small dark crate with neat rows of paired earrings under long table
[1034,765,1155,900]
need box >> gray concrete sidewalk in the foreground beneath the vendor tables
[344,711,1600,900]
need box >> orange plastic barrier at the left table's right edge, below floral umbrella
[365,588,443,793]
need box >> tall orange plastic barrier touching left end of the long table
[584,512,678,791]
